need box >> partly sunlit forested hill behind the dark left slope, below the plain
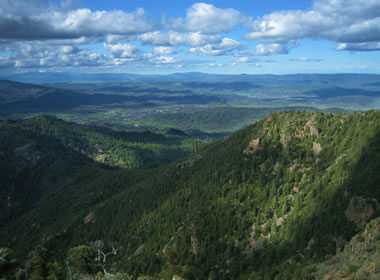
[9,115,199,168]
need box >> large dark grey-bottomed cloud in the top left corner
[0,0,153,40]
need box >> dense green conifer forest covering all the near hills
[0,111,380,279]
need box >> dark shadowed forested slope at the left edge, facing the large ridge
[0,121,94,224]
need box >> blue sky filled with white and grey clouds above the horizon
[0,0,380,74]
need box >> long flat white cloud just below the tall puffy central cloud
[137,31,221,47]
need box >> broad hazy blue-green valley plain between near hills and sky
[0,73,380,138]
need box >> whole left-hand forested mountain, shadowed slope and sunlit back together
[0,115,200,235]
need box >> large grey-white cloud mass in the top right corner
[245,0,380,50]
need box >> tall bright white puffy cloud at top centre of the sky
[172,3,246,33]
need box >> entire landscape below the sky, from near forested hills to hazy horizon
[0,74,380,279]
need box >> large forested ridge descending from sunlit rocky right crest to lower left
[0,111,380,279]
